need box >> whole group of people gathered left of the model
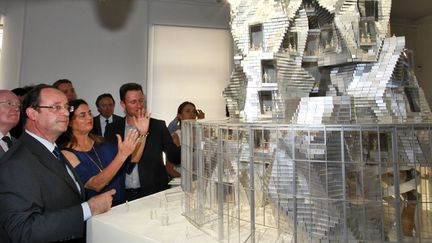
[0,79,204,242]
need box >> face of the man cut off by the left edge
[0,90,21,131]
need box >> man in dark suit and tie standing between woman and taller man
[92,93,121,136]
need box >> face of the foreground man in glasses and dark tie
[29,88,69,141]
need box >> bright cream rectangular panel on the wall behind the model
[147,25,232,123]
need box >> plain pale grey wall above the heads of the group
[0,0,229,115]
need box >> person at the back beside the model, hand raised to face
[165,101,205,177]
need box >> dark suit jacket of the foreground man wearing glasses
[0,132,85,242]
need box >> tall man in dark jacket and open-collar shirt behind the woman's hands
[105,83,180,200]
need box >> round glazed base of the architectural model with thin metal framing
[182,122,432,242]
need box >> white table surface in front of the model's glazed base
[87,186,217,243]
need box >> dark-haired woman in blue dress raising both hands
[62,99,149,206]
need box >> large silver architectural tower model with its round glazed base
[182,0,432,242]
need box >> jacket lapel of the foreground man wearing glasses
[21,132,84,198]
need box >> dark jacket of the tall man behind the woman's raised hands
[105,118,180,194]
